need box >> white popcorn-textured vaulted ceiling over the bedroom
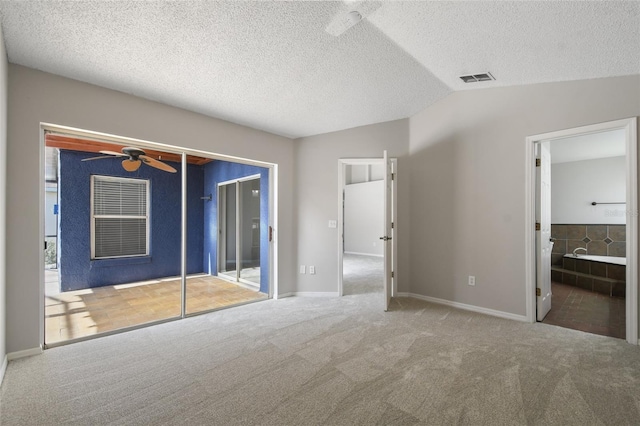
[0,1,640,137]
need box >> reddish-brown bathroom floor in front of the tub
[542,282,626,339]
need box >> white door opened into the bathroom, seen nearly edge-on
[536,141,553,321]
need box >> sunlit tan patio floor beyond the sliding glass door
[45,270,267,344]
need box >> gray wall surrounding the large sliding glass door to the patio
[6,64,295,352]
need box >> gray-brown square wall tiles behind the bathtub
[551,224,627,265]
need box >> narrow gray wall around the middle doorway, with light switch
[295,119,411,292]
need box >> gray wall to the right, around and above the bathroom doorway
[409,76,640,315]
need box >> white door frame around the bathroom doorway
[525,117,638,345]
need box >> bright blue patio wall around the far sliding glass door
[203,161,269,293]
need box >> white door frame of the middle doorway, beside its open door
[337,158,398,296]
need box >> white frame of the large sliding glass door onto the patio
[38,122,279,347]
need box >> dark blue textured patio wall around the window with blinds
[58,150,202,291]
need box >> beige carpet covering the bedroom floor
[0,255,640,425]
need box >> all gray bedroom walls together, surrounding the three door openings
[5,61,640,354]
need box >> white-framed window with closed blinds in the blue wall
[91,175,149,259]
